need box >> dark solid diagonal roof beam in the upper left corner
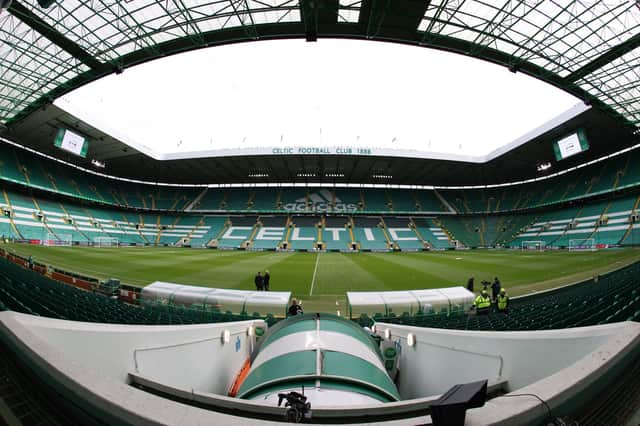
[8,0,113,73]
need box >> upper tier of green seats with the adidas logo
[5,143,640,215]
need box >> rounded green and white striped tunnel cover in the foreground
[238,314,400,407]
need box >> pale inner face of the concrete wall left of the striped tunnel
[8,315,266,395]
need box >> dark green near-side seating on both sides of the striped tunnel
[0,243,640,336]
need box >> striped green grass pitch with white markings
[3,244,640,312]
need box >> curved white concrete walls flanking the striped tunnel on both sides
[0,312,640,426]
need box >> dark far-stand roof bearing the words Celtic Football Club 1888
[3,101,639,186]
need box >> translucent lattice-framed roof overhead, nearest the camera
[0,0,640,131]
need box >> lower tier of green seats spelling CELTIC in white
[5,177,640,250]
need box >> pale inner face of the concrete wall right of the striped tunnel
[376,323,636,399]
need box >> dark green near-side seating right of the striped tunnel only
[357,262,640,331]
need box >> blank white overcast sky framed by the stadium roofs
[57,39,579,156]
